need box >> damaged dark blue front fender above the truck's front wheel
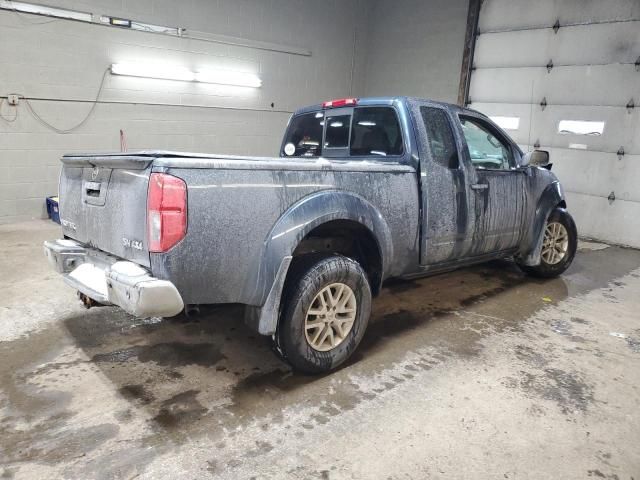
[519,180,564,266]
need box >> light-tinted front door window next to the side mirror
[460,117,514,170]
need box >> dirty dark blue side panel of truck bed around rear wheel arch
[151,160,419,305]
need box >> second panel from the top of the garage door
[474,22,640,68]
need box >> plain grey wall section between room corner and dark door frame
[362,0,468,103]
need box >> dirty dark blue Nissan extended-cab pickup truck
[45,97,577,372]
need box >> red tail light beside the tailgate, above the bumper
[147,173,187,252]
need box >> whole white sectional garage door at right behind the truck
[469,0,640,247]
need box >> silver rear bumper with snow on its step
[44,239,184,317]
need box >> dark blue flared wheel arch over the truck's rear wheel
[247,190,393,305]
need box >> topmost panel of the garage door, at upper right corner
[478,0,640,33]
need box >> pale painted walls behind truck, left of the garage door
[0,0,467,223]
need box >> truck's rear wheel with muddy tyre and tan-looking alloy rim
[276,255,371,373]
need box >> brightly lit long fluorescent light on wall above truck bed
[111,63,262,88]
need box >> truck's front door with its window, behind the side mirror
[460,115,526,256]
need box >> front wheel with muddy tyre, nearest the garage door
[520,208,578,278]
